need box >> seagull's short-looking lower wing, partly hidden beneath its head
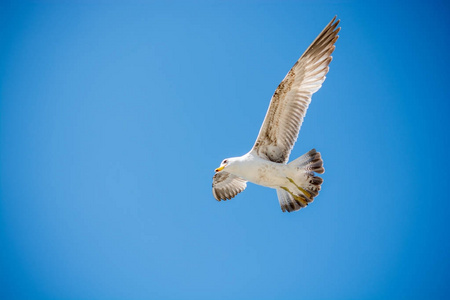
[213,171,247,201]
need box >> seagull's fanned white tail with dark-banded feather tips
[277,149,325,212]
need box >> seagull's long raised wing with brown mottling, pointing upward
[252,17,341,163]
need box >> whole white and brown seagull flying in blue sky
[212,16,341,212]
